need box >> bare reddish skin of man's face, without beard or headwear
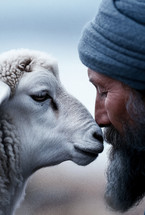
[88,69,131,133]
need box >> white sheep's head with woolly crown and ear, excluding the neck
[0,49,103,171]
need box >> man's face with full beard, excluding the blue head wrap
[88,69,145,212]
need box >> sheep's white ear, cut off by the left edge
[0,81,11,105]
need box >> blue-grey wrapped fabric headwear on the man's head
[78,0,145,91]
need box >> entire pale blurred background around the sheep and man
[0,0,145,215]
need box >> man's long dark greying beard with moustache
[104,124,145,212]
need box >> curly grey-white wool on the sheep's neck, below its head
[0,117,24,215]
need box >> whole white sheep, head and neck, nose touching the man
[0,49,103,215]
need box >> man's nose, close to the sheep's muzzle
[95,97,111,127]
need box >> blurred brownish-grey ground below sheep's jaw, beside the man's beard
[16,145,145,215]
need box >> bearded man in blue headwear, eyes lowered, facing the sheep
[78,0,145,212]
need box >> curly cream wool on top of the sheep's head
[0,49,58,93]
